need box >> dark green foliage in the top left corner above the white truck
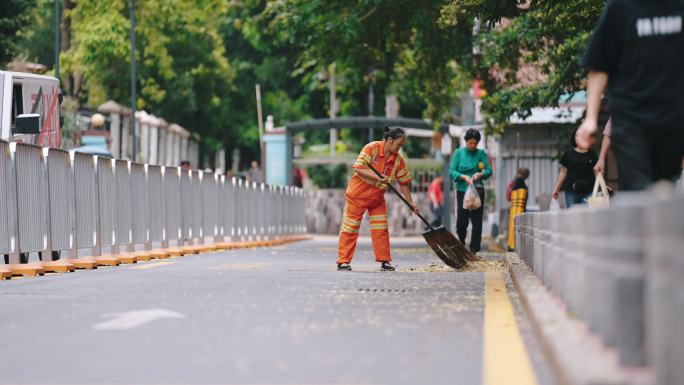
[0,0,35,67]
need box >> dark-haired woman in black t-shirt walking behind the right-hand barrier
[553,128,598,208]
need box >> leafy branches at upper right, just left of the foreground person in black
[442,0,606,132]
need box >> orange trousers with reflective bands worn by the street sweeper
[337,198,392,263]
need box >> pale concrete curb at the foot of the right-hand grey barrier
[504,253,653,385]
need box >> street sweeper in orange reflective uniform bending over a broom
[337,126,418,271]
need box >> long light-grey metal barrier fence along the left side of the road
[0,141,305,263]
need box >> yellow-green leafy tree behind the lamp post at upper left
[62,0,236,159]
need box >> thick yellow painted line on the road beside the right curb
[482,272,537,385]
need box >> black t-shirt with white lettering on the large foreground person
[583,0,684,129]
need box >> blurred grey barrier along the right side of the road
[515,194,684,384]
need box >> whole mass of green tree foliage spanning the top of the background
[6,0,605,162]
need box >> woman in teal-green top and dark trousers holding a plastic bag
[449,129,492,253]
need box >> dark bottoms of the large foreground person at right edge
[611,119,684,191]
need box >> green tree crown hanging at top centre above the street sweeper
[264,0,470,121]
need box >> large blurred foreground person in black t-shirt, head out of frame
[577,0,684,190]
